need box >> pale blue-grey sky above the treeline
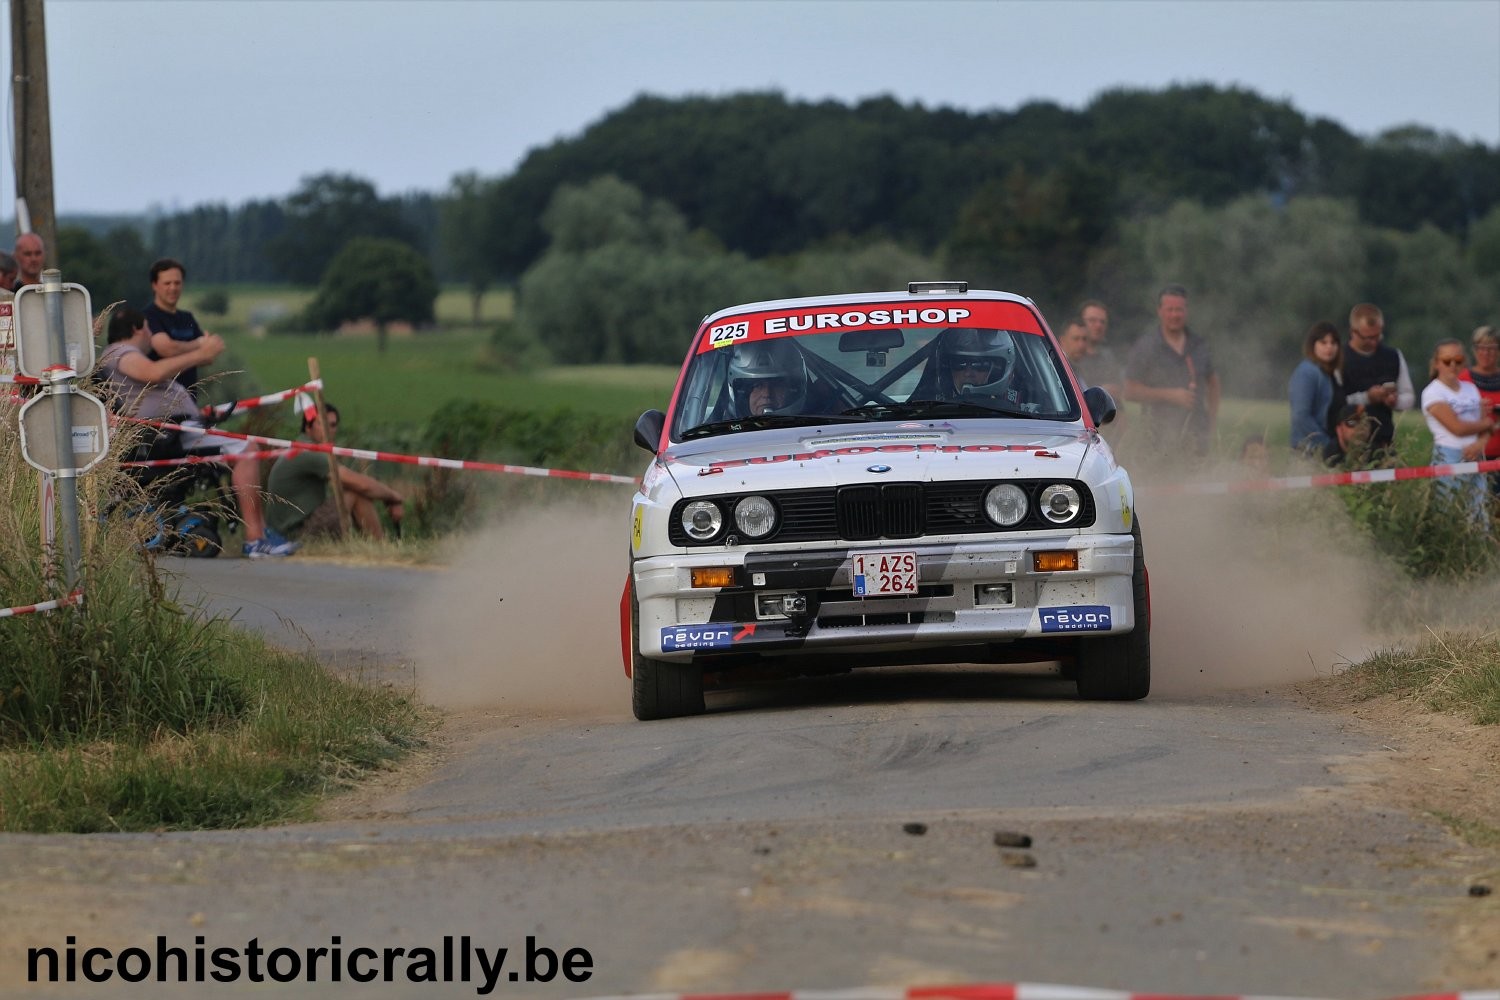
[0,0,1500,214]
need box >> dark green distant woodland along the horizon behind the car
[41,85,1500,391]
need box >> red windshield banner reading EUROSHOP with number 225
[698,298,1041,354]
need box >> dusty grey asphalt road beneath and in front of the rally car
[0,559,1476,999]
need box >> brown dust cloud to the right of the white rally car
[1139,490,1383,694]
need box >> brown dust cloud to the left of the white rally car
[413,501,630,717]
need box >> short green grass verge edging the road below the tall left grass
[0,632,429,834]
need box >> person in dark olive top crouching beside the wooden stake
[266,402,405,538]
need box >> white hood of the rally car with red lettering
[662,420,1095,496]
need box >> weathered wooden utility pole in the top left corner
[11,0,57,257]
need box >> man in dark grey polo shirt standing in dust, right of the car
[1125,285,1220,456]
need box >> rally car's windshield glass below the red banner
[672,313,1080,441]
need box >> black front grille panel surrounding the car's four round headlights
[668,480,1095,546]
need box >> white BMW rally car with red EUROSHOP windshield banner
[620,282,1151,720]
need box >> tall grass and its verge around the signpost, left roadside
[0,403,425,831]
